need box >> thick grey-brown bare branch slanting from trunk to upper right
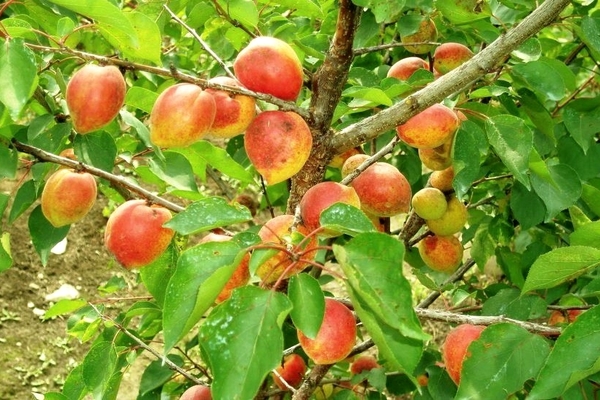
[332,0,570,154]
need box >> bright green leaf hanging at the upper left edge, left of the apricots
[0,39,38,120]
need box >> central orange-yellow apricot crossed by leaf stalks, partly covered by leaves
[256,214,318,284]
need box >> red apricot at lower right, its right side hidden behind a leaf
[442,324,485,385]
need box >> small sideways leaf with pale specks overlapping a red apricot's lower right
[319,203,376,236]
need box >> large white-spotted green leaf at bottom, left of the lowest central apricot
[199,286,292,400]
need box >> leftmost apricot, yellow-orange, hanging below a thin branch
[41,168,97,228]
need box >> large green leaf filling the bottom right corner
[527,306,600,400]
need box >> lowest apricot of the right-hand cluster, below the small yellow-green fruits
[418,235,463,273]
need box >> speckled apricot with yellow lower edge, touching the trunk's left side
[244,111,312,185]
